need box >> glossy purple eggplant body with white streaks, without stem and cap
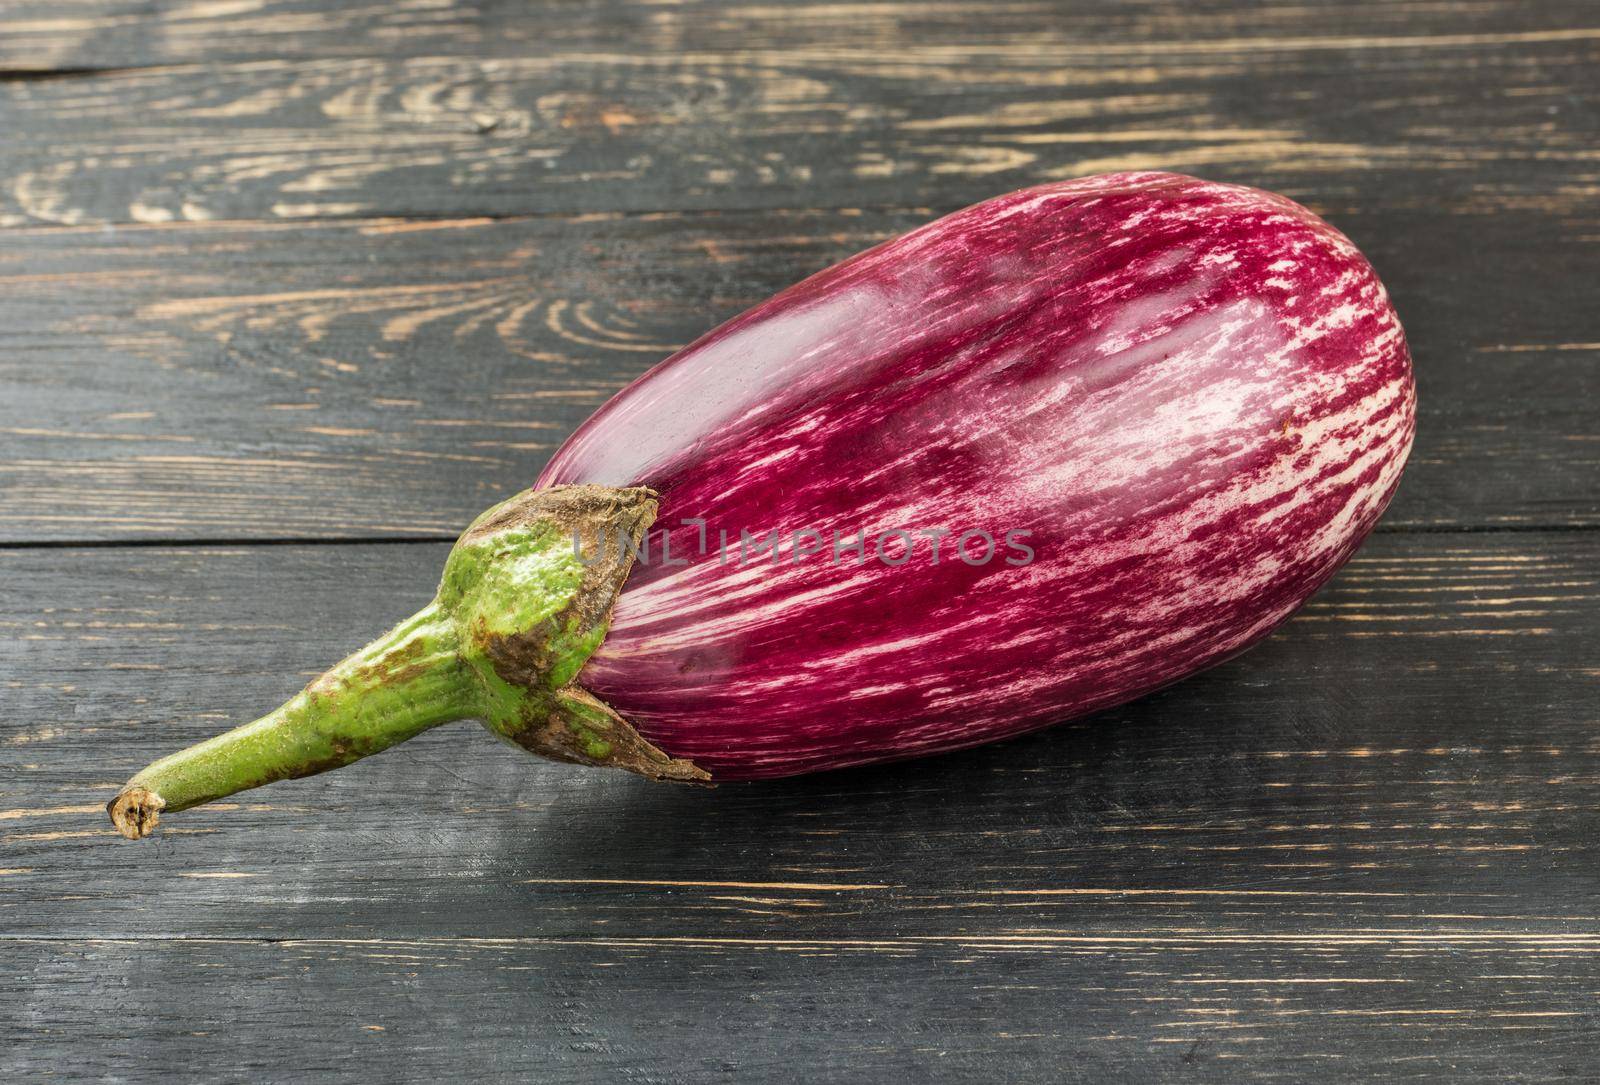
[539,173,1416,779]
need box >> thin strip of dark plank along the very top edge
[0,0,1592,75]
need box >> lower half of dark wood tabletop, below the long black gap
[0,531,1600,1080]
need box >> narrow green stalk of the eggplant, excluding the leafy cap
[107,603,480,839]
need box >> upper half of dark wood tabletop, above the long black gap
[0,0,1600,541]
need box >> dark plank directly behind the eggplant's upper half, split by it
[0,208,1600,541]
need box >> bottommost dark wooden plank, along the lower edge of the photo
[0,928,1597,1085]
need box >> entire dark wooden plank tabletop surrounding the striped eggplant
[0,0,1600,1083]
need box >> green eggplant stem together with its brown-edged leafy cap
[106,485,707,840]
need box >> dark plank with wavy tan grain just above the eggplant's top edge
[0,11,1600,224]
